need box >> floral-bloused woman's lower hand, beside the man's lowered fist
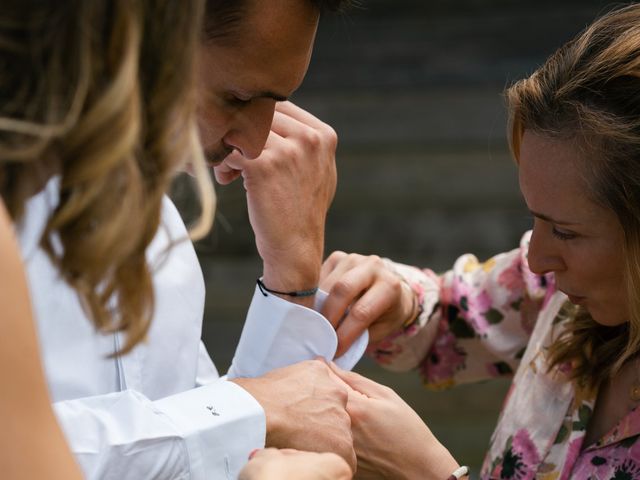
[331,364,459,480]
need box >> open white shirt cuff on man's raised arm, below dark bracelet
[228,287,369,378]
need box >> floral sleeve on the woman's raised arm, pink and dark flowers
[368,232,555,389]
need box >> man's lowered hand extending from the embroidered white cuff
[232,360,356,470]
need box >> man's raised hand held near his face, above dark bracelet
[215,102,338,304]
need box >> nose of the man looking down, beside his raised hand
[223,98,276,159]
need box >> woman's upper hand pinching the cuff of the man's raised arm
[320,252,419,357]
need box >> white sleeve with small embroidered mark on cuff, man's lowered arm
[54,380,266,480]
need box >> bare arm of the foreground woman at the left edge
[0,197,81,480]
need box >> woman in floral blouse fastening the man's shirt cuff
[323,4,640,479]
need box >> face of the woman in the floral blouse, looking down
[519,131,629,326]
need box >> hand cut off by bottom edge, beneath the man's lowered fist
[238,448,351,480]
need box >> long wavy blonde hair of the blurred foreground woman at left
[0,0,215,353]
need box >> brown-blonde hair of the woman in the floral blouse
[506,4,640,387]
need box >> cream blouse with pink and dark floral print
[370,234,640,480]
